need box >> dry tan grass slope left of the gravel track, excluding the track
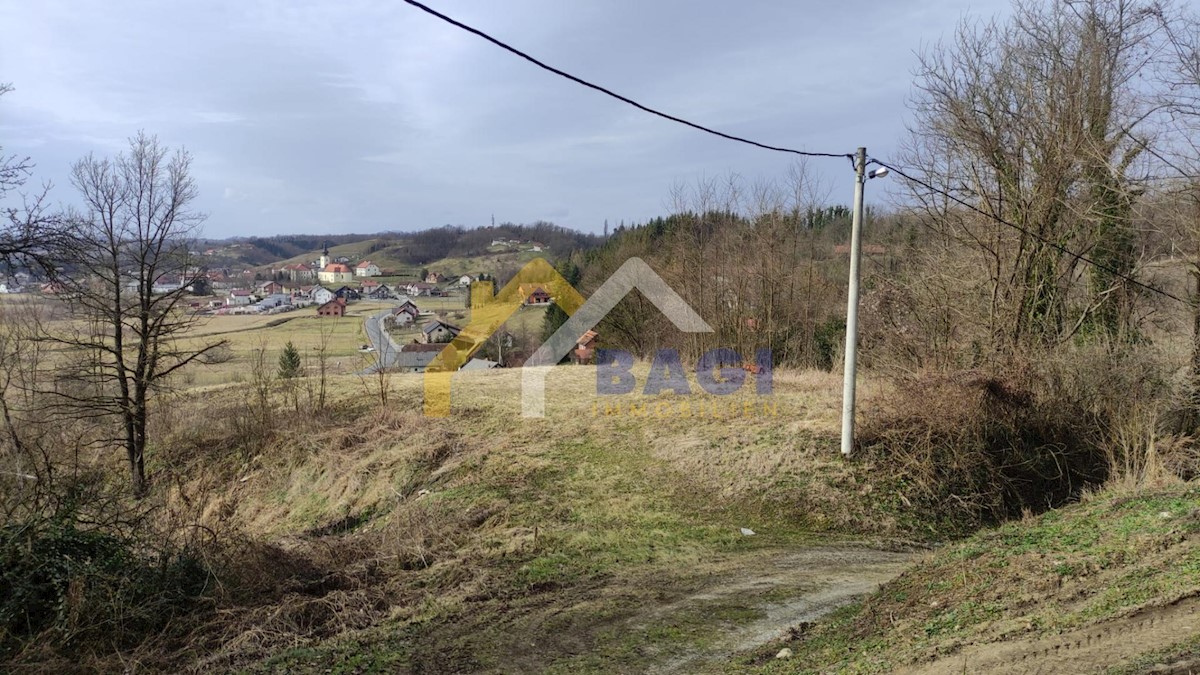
[51,366,896,669]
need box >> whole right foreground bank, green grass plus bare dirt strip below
[733,484,1200,675]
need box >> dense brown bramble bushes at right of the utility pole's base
[859,348,1190,530]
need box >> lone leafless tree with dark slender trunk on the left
[52,133,224,497]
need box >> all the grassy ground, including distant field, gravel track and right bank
[14,290,1200,674]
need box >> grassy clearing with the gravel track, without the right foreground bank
[136,362,908,673]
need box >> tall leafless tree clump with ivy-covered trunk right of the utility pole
[910,0,1162,350]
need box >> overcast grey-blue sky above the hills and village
[0,0,1007,237]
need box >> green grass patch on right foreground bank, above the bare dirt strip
[734,485,1200,673]
